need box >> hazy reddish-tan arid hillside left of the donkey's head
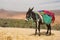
[0,9,26,19]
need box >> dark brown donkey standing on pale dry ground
[26,8,51,36]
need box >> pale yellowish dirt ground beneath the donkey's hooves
[0,27,60,40]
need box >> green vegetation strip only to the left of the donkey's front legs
[0,19,34,28]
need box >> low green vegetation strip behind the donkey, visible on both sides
[0,19,60,30]
